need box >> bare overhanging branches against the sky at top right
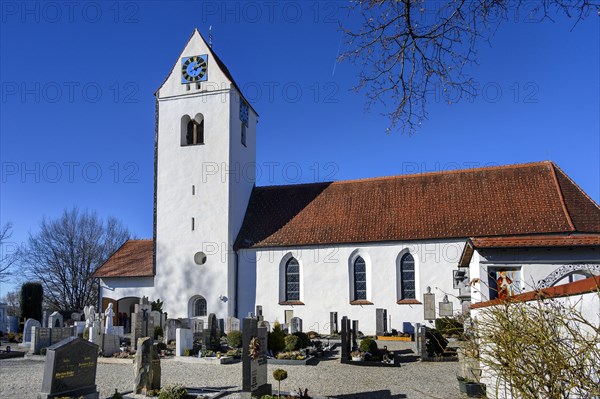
[340,0,599,133]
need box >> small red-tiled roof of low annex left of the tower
[94,240,154,277]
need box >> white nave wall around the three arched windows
[239,240,464,334]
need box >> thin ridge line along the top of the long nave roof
[256,161,553,189]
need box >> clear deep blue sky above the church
[0,0,600,296]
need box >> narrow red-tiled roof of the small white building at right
[471,234,600,249]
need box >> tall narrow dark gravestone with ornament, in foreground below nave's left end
[242,318,272,398]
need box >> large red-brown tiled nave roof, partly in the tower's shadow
[236,162,600,248]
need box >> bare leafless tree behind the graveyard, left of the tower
[19,208,130,310]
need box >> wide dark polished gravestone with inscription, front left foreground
[38,337,100,399]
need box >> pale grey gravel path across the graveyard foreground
[0,343,463,399]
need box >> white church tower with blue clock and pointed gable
[154,30,257,318]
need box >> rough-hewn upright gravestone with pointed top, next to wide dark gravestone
[133,337,160,395]
